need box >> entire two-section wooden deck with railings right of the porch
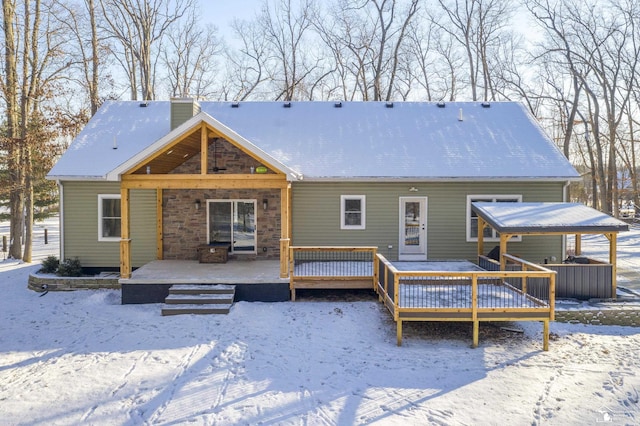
[289,247,556,351]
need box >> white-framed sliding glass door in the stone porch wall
[207,200,256,254]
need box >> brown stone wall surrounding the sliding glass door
[162,189,281,260]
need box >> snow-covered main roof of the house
[49,101,579,180]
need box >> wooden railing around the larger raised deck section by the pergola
[376,254,555,350]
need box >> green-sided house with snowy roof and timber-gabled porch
[48,99,579,300]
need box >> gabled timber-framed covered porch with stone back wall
[113,105,297,280]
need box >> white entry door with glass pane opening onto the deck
[398,197,427,260]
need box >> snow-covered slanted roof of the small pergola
[471,202,629,234]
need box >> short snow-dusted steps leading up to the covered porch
[162,284,236,316]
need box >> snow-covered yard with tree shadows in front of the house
[0,218,640,425]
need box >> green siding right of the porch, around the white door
[292,182,564,262]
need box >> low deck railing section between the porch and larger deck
[289,246,378,300]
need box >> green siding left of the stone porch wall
[63,182,156,268]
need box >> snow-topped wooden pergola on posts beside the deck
[471,202,629,297]
